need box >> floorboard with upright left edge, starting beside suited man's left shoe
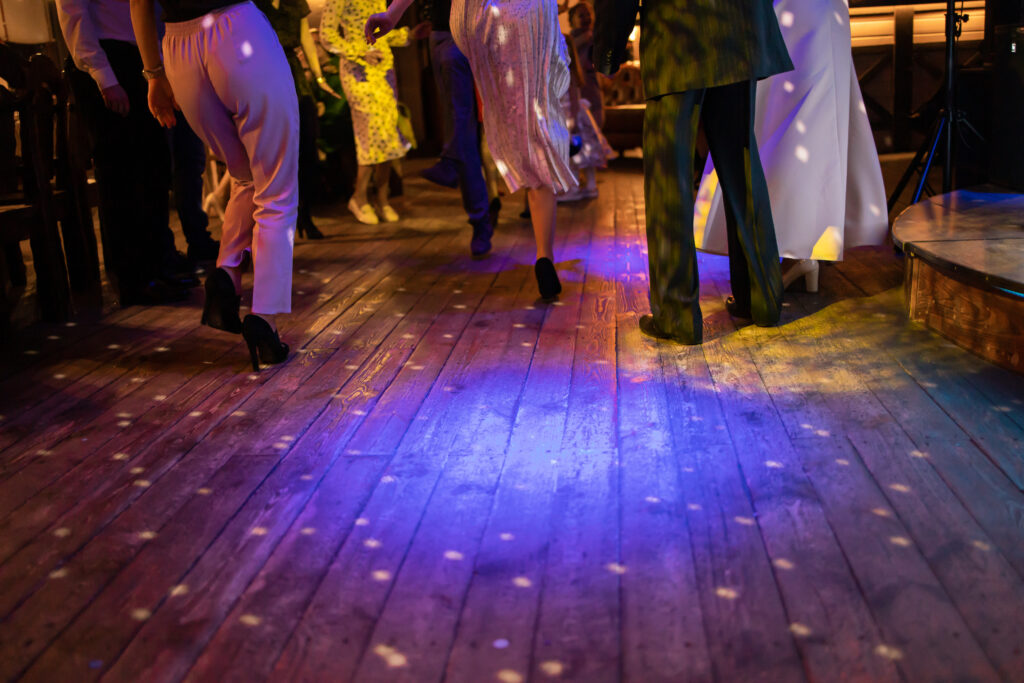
[616,167,712,681]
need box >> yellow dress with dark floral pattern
[319,0,411,166]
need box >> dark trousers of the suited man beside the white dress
[643,81,782,342]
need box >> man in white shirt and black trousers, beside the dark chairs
[56,0,195,306]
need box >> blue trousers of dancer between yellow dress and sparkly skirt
[430,31,489,222]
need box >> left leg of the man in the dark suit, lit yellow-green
[643,90,703,344]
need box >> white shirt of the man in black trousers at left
[56,0,135,90]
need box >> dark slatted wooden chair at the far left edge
[0,44,99,326]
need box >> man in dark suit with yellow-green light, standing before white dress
[594,0,798,344]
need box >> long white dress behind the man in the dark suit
[693,0,889,261]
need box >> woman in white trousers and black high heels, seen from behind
[131,0,299,371]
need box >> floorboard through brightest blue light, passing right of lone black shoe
[445,183,614,681]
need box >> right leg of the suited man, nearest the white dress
[702,81,782,325]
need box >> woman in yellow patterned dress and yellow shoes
[319,0,430,225]
